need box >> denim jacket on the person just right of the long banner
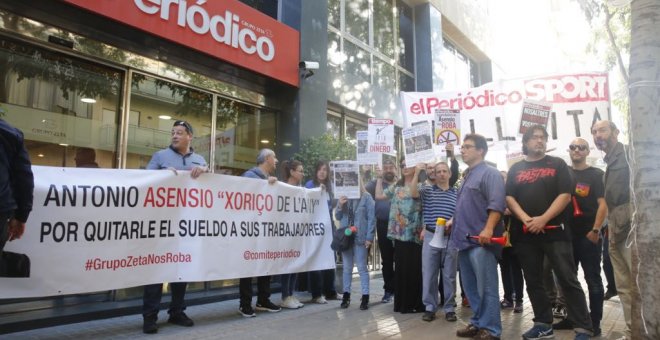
[335,192,376,244]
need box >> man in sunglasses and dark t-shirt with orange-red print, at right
[552,138,607,336]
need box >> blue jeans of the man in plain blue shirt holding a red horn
[458,247,502,337]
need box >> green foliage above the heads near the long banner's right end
[293,133,356,178]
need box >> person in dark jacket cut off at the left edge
[0,119,34,276]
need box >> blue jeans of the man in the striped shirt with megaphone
[422,232,458,313]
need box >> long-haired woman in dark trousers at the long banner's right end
[305,161,337,304]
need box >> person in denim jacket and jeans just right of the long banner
[335,175,376,310]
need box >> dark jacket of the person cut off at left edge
[0,119,34,222]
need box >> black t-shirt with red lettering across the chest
[506,155,573,245]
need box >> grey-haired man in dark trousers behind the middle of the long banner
[238,149,281,318]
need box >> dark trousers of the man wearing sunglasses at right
[573,236,605,329]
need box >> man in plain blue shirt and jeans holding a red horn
[448,134,505,339]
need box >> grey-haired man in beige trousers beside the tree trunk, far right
[591,120,635,338]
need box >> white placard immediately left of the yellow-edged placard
[401,122,435,167]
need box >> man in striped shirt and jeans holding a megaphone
[419,162,457,322]
